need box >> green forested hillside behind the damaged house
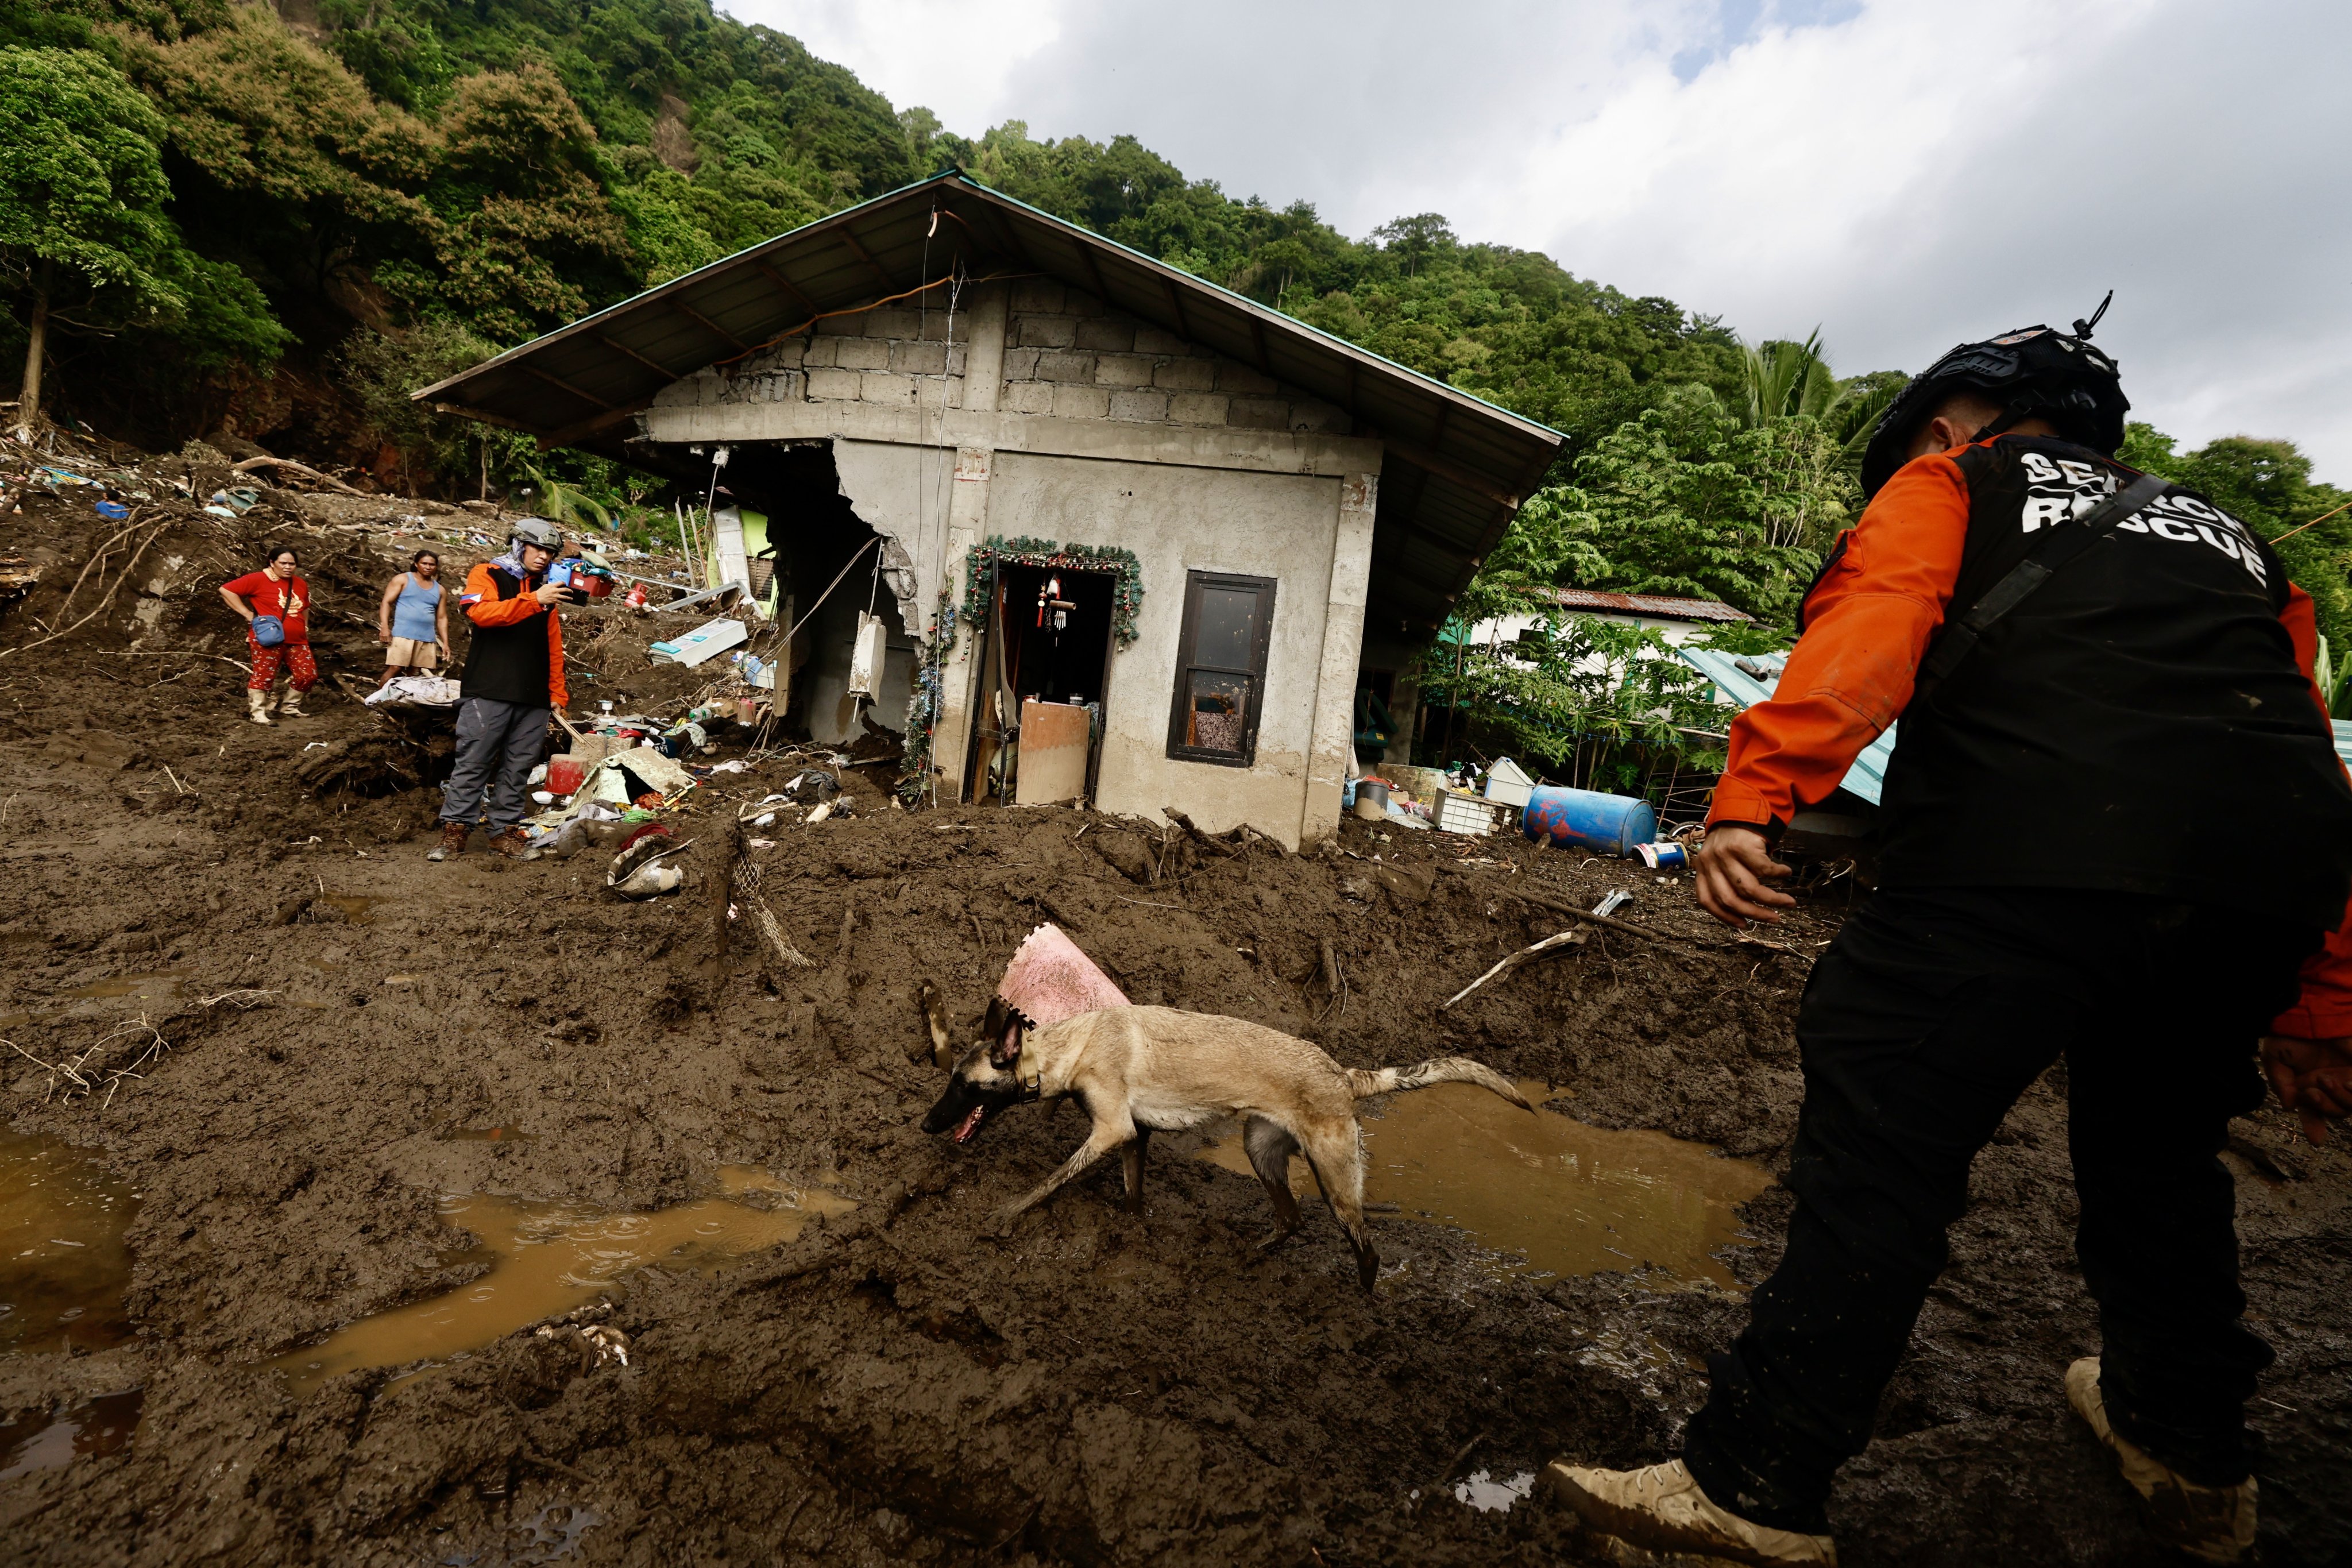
[0,0,2352,667]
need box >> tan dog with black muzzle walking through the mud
[922,997,1534,1291]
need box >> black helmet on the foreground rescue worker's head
[1863,294,2131,501]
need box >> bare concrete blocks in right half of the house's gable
[999,277,1353,435]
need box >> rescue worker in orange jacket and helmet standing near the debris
[426,517,578,860]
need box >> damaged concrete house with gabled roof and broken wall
[419,172,1562,846]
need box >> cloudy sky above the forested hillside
[722,0,2352,484]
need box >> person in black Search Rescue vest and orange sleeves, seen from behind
[1548,306,2352,1563]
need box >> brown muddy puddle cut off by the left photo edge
[0,1129,139,1354]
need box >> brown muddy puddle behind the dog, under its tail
[1202,1082,1774,1288]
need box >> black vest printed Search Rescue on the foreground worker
[1879,435,2352,929]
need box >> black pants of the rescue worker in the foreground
[1684,889,2322,1533]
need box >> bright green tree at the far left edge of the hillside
[0,47,287,423]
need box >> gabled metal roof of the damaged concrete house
[416,172,1566,630]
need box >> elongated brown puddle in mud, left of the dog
[271,1166,856,1399]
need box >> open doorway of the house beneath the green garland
[964,562,1117,806]
